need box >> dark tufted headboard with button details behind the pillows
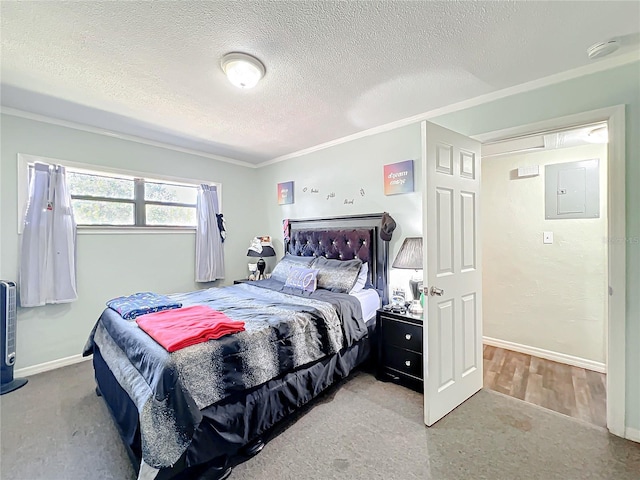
[285,213,389,305]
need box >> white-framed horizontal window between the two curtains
[19,154,220,231]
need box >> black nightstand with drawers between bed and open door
[376,309,424,392]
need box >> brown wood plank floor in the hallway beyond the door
[483,345,607,427]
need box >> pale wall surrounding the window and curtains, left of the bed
[0,115,262,369]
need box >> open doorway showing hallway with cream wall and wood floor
[480,122,608,427]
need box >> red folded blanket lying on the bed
[136,305,244,352]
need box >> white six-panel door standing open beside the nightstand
[422,122,482,426]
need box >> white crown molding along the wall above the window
[0,106,257,168]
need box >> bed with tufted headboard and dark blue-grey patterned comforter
[84,214,388,480]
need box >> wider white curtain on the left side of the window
[19,163,78,307]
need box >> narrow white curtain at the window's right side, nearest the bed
[196,184,224,282]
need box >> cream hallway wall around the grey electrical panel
[480,145,607,363]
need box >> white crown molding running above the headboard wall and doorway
[257,49,640,168]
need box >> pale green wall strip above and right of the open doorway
[432,62,640,430]
